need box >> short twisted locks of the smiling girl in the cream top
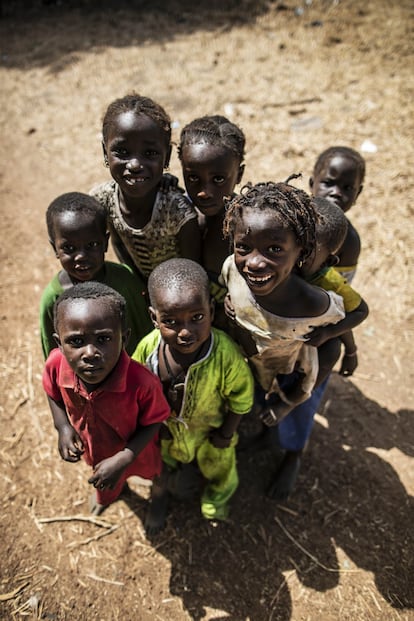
[223,181,318,261]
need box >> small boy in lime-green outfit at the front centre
[133,259,253,534]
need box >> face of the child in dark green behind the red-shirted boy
[52,212,108,282]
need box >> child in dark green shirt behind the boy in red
[40,192,152,360]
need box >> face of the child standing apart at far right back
[310,155,362,213]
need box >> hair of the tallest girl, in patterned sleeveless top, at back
[102,93,171,146]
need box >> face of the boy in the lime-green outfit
[150,288,213,355]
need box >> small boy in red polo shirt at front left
[43,281,170,515]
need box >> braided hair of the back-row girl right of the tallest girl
[178,114,246,162]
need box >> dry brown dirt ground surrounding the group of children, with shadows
[0,0,414,621]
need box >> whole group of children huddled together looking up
[40,94,368,534]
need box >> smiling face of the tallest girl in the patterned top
[103,112,170,198]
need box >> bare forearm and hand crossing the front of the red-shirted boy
[88,423,161,489]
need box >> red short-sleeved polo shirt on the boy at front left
[43,349,170,505]
